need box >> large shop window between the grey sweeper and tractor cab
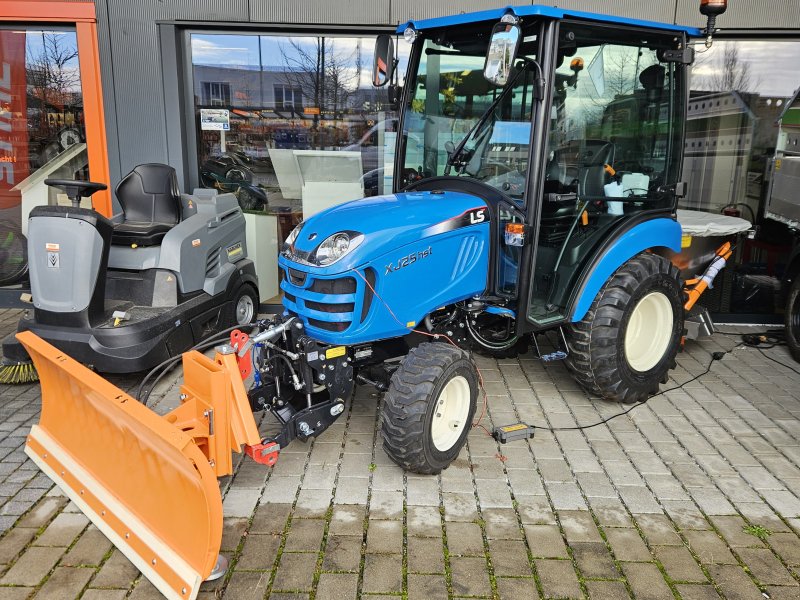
[191,34,409,237]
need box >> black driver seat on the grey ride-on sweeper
[111,163,181,246]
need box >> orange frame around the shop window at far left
[0,0,112,217]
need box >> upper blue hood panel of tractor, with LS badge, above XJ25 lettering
[282,191,489,274]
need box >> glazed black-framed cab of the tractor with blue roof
[376,6,691,332]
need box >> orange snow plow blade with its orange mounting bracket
[17,332,268,599]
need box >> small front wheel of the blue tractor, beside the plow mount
[381,342,478,475]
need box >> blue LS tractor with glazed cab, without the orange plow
[251,1,725,473]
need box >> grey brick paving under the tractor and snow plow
[0,311,800,600]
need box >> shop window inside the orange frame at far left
[0,27,90,285]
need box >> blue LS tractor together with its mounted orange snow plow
[18,0,729,598]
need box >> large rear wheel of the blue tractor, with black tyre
[566,253,683,404]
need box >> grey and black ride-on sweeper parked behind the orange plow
[0,164,258,383]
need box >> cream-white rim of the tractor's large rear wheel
[625,292,675,372]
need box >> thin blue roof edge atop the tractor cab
[397,4,702,37]
